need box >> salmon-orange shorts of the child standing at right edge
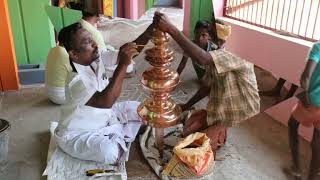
[292,101,320,129]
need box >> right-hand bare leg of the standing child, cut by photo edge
[308,128,320,180]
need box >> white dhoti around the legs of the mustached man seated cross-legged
[55,101,141,164]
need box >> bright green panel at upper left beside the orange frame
[8,0,55,65]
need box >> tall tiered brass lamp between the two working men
[138,28,181,154]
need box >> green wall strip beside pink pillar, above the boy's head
[189,0,213,39]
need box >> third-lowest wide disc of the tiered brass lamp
[145,47,174,67]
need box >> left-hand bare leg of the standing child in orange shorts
[288,116,301,180]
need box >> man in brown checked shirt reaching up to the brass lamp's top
[154,12,260,150]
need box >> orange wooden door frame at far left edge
[0,0,19,91]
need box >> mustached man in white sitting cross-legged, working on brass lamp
[55,23,150,164]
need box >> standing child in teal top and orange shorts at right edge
[288,42,320,180]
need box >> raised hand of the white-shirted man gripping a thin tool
[119,42,139,66]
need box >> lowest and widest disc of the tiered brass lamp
[137,99,182,128]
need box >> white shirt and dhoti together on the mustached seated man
[55,58,141,164]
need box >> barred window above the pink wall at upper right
[224,0,320,41]
